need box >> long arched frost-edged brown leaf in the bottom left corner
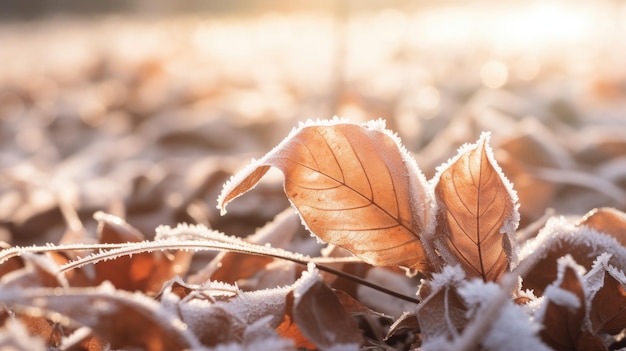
[0,284,198,351]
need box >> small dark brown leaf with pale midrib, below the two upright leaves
[416,265,468,343]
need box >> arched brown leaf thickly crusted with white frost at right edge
[520,218,626,296]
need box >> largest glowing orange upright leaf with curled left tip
[218,121,429,270]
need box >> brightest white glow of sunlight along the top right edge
[411,0,610,53]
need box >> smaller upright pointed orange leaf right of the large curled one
[435,134,519,281]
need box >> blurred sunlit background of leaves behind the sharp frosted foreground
[0,0,626,248]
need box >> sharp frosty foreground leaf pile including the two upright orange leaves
[0,118,626,350]
